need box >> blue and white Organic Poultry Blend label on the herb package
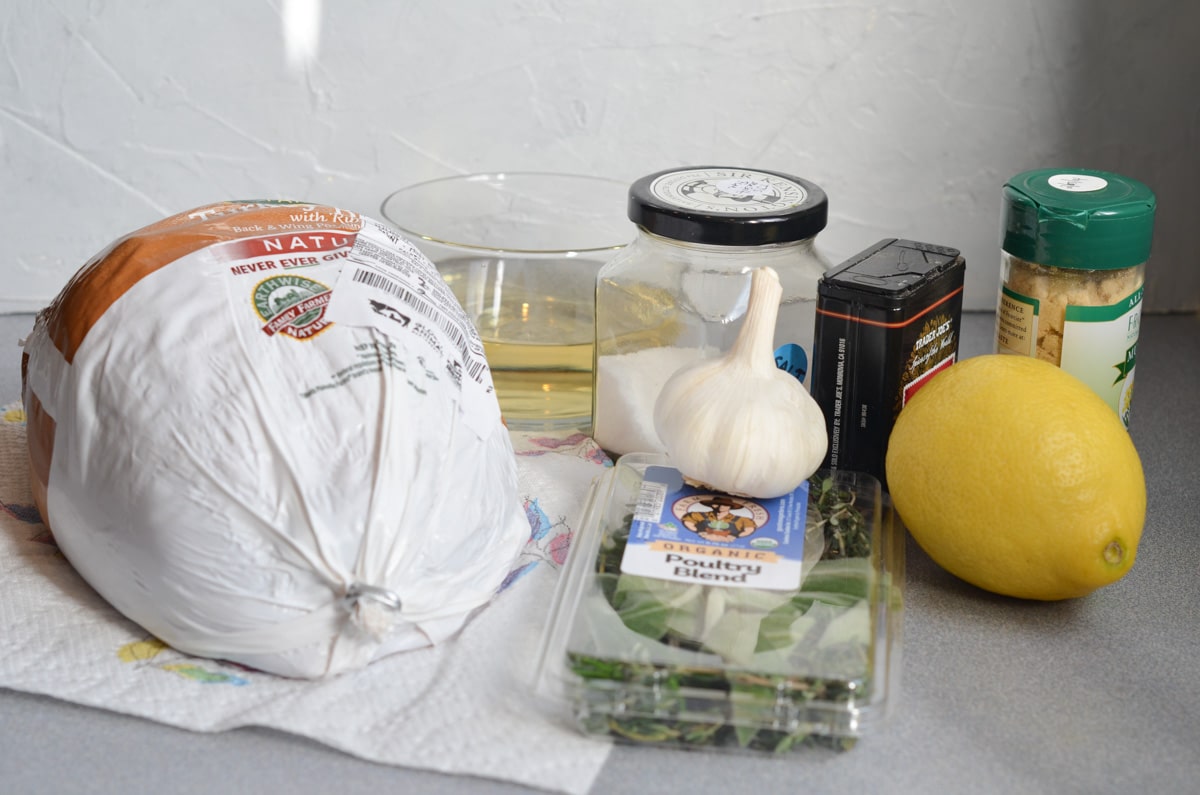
[620,466,820,591]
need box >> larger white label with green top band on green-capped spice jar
[1060,287,1142,428]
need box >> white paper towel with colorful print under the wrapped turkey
[0,404,610,794]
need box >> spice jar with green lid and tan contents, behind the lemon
[996,168,1156,428]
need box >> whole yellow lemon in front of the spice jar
[886,354,1146,599]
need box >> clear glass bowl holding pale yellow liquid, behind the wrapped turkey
[380,172,635,431]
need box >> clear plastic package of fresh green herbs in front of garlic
[536,453,904,754]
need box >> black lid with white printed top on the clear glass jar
[629,166,829,246]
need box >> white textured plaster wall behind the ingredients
[0,0,1200,311]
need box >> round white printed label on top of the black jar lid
[650,168,809,215]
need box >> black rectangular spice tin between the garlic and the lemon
[811,238,966,488]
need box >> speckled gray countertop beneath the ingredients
[0,313,1200,795]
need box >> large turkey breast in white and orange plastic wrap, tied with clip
[22,202,529,677]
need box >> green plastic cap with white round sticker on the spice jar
[1003,168,1156,270]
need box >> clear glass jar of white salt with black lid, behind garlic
[593,167,830,455]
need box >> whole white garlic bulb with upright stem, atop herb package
[654,268,829,498]
